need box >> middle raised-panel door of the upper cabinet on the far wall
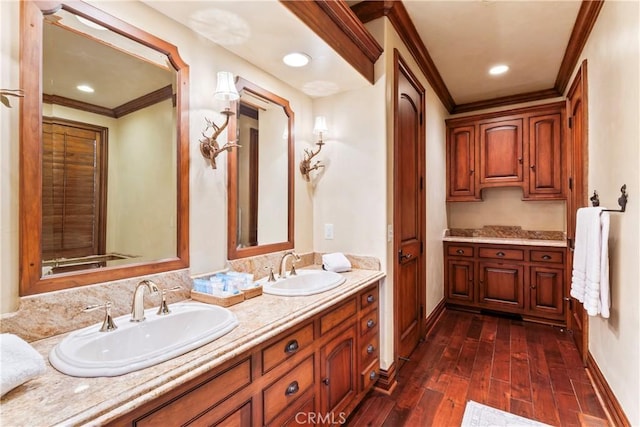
[480,119,523,184]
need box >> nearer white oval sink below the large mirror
[49,302,238,377]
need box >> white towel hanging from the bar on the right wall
[571,207,609,318]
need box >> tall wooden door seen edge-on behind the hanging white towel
[565,60,589,364]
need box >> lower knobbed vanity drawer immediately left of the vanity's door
[262,355,315,424]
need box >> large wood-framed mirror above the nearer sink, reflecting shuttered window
[20,1,189,296]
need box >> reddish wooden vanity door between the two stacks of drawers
[320,325,358,414]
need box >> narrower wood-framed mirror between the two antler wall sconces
[227,78,294,259]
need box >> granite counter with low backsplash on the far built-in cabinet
[442,225,567,248]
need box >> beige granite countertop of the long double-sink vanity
[0,266,385,426]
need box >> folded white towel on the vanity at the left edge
[0,334,46,396]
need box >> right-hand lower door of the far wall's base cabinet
[529,265,564,317]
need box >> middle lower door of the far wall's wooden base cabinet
[478,262,524,312]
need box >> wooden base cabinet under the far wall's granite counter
[444,242,566,325]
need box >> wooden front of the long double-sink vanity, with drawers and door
[109,283,379,427]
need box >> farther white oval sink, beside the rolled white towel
[261,270,346,296]
